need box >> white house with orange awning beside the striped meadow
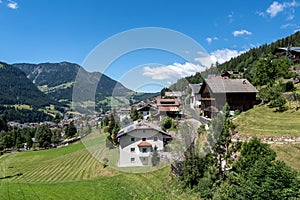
[117,121,171,167]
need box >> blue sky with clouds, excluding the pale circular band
[0,0,300,89]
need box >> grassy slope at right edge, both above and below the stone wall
[234,106,300,171]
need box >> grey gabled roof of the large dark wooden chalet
[205,78,258,93]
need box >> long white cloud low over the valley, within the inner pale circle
[143,62,205,80]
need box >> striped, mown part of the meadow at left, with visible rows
[0,143,113,183]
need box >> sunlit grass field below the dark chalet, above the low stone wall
[233,105,300,137]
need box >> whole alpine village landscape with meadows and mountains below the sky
[0,32,300,200]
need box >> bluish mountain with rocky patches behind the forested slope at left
[13,62,156,110]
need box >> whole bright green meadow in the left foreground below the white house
[0,130,197,199]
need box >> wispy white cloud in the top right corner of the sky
[266,0,300,20]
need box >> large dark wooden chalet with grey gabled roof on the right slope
[200,78,258,118]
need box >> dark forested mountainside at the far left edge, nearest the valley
[0,62,60,122]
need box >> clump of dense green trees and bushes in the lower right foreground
[172,104,300,200]
